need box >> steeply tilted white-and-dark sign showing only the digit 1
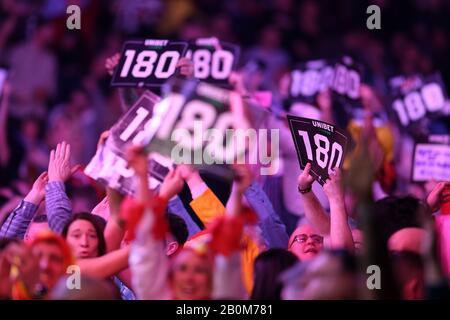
[84,91,170,194]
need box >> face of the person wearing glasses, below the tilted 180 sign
[288,225,323,261]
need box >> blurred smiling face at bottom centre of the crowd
[172,249,212,300]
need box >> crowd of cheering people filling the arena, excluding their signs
[0,0,450,300]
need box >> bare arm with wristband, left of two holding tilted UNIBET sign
[297,163,330,236]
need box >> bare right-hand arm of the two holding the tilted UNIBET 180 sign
[323,168,354,252]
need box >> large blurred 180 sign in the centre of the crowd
[147,76,249,179]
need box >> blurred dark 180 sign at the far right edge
[390,73,448,129]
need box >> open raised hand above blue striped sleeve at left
[48,141,80,182]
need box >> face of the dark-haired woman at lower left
[66,219,98,259]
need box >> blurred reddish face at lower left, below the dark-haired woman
[32,242,65,289]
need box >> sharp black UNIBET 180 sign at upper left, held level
[111,39,188,87]
